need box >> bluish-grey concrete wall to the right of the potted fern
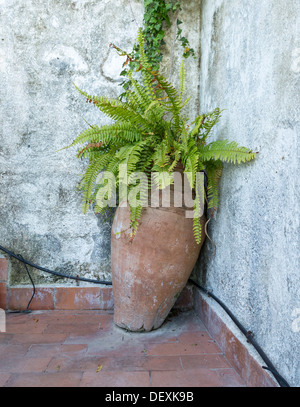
[196,0,300,386]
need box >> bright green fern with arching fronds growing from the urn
[68,30,255,243]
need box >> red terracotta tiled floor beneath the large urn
[0,310,245,388]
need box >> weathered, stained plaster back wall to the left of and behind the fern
[0,0,200,284]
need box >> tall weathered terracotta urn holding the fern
[111,200,205,331]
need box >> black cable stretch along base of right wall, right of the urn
[189,279,290,387]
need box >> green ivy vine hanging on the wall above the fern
[120,0,195,99]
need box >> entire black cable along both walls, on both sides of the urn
[0,246,290,387]
